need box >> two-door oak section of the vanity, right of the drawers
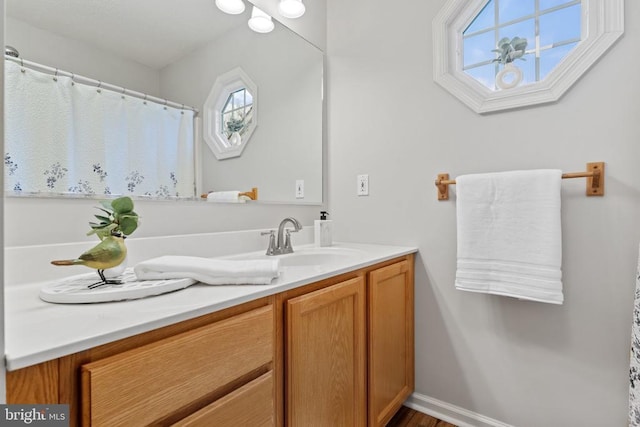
[278,255,414,426]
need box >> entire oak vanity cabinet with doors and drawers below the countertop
[6,254,414,427]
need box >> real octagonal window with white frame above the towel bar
[433,0,624,113]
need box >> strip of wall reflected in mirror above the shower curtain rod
[6,18,160,96]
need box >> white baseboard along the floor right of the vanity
[404,393,513,427]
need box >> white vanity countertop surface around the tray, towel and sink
[5,243,418,371]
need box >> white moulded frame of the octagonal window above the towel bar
[433,0,624,114]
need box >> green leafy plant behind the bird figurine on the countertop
[87,196,138,240]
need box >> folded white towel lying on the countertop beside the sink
[133,255,280,285]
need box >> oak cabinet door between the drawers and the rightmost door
[285,276,366,427]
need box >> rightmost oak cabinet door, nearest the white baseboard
[368,258,414,426]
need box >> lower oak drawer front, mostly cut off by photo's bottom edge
[174,371,275,427]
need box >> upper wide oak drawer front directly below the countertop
[82,305,274,427]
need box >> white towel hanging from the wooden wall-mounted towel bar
[455,169,563,304]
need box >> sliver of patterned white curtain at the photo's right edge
[629,244,640,427]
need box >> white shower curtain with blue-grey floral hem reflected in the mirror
[4,61,195,198]
